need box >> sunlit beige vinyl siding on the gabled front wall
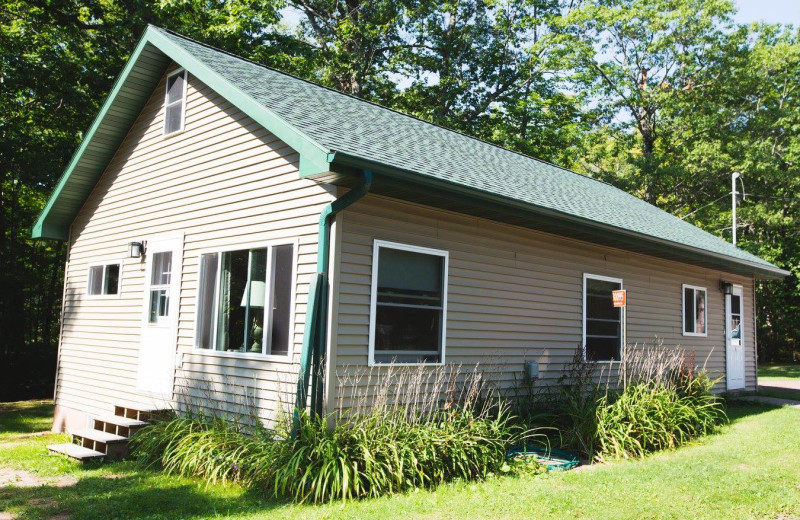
[56,66,333,424]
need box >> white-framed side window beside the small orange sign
[583,274,622,361]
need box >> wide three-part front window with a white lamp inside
[196,244,295,356]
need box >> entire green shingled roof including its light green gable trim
[34,26,788,278]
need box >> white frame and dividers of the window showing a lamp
[189,238,300,363]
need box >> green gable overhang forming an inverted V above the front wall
[31,26,333,240]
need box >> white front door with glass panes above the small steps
[138,237,183,397]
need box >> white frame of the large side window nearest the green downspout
[368,239,450,366]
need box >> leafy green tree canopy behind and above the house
[0,0,800,400]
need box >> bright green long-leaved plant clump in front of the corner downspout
[275,404,521,502]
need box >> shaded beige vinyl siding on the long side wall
[332,195,755,406]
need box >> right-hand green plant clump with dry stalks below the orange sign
[520,343,727,460]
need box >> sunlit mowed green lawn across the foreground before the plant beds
[0,402,800,520]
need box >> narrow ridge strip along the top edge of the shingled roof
[148,24,616,190]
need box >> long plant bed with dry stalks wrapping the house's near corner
[132,366,535,502]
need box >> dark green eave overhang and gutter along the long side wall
[307,153,790,280]
